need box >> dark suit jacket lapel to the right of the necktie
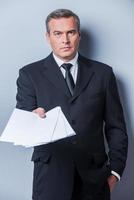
[70,55,94,101]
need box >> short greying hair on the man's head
[46,9,80,33]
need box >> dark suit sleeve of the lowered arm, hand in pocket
[105,71,128,176]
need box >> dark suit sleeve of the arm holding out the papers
[16,69,37,111]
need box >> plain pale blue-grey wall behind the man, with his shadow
[0,0,134,200]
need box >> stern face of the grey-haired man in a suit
[46,17,80,62]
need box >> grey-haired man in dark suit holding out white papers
[17,9,127,200]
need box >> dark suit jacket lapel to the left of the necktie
[44,54,70,97]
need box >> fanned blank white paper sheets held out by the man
[0,107,75,147]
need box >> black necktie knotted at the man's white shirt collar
[61,63,75,95]
